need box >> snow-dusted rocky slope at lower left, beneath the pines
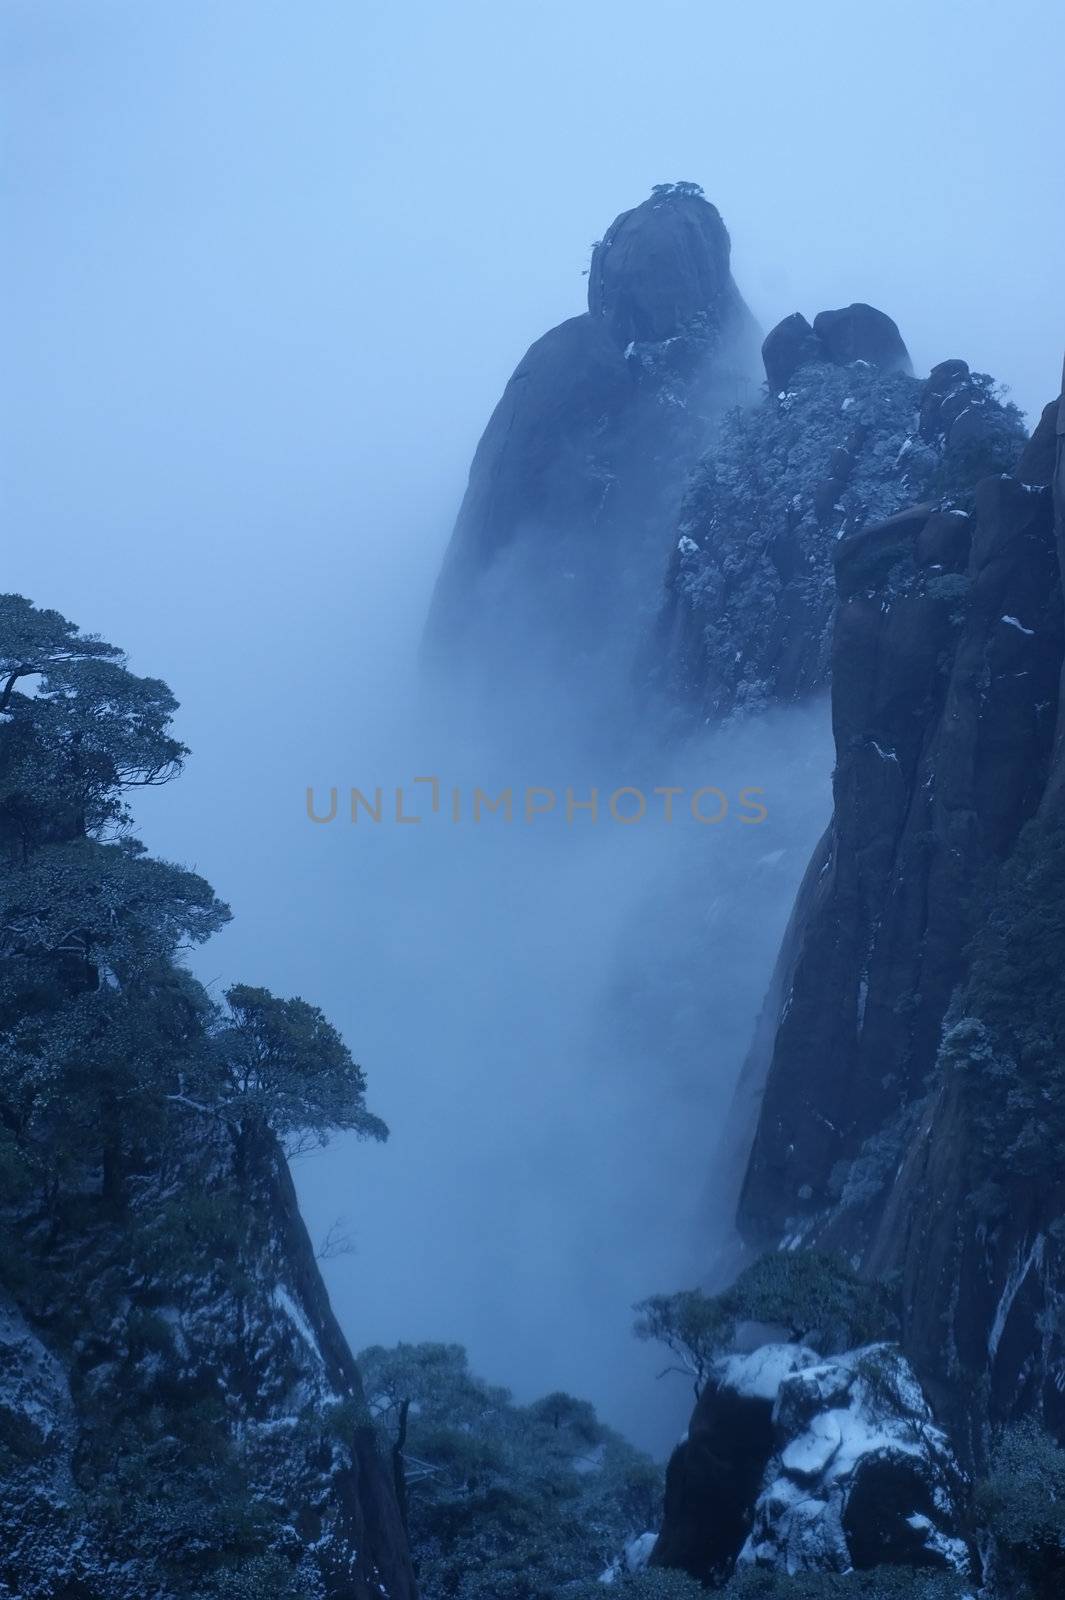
[0,1114,416,1600]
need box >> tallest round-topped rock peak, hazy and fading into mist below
[425,184,756,697]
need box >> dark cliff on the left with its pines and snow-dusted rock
[0,595,414,1600]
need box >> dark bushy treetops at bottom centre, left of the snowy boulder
[358,1344,662,1600]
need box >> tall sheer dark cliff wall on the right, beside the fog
[740,478,1062,1240]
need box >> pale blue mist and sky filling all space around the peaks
[2,0,1062,1451]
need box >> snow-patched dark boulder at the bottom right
[651,1344,969,1582]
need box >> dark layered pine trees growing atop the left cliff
[0,594,387,1194]
